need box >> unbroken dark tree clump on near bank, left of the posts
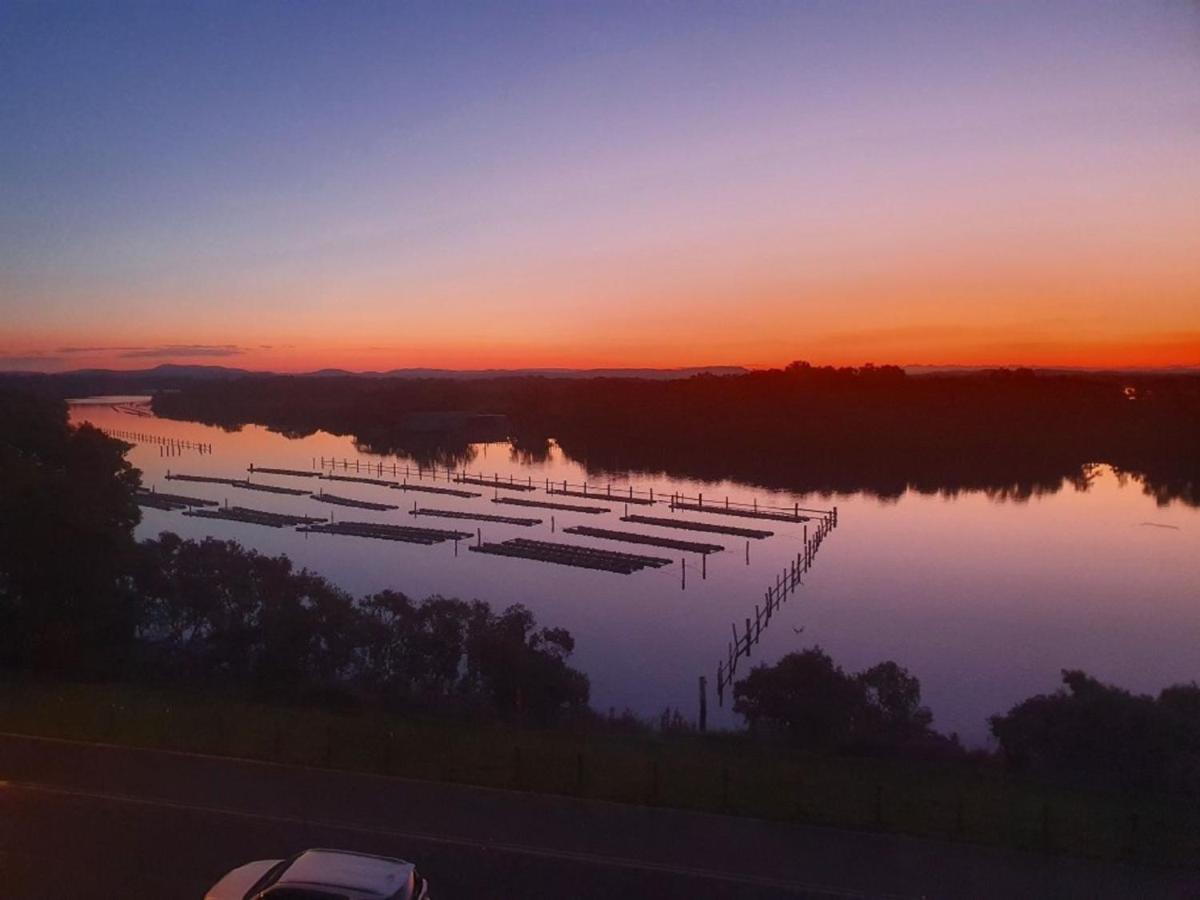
[0,391,589,724]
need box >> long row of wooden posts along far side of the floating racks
[312,456,830,521]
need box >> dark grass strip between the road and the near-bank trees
[0,682,1200,865]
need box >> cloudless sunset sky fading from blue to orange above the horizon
[0,0,1200,371]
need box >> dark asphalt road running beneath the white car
[0,736,1200,900]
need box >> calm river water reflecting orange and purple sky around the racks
[73,404,1200,743]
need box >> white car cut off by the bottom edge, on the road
[204,850,430,900]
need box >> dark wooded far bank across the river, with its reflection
[154,362,1200,505]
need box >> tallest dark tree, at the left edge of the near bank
[0,392,139,676]
